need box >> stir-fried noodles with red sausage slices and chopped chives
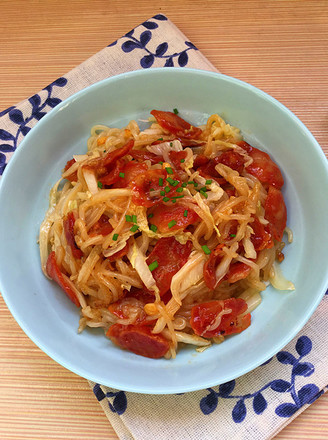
[39,109,294,358]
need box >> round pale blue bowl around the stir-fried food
[0,68,328,394]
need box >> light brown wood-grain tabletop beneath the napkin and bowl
[0,0,328,440]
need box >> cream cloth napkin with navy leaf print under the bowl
[0,14,328,440]
